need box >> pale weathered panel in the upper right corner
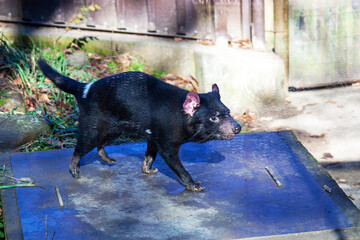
[289,0,360,87]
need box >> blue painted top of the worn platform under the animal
[11,133,353,239]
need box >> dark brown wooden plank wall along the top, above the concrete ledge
[0,0,263,42]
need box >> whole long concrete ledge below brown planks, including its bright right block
[0,24,287,113]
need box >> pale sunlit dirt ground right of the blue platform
[248,85,360,208]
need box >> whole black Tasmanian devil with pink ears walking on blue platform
[38,59,241,191]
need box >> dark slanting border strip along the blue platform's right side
[276,131,360,235]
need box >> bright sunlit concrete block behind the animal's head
[195,47,287,113]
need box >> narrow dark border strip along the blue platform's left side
[0,151,24,240]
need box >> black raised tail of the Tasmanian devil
[37,58,85,96]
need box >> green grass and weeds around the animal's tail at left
[0,34,80,151]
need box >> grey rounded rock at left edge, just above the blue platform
[0,114,51,149]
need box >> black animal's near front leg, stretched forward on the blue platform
[159,145,205,192]
